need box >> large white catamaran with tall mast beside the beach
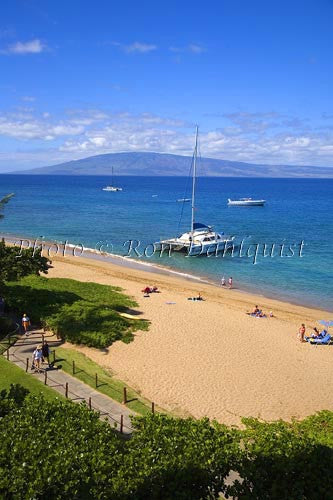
[157,126,232,255]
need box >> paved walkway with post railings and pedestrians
[4,330,135,434]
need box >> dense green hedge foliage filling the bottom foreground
[0,387,333,500]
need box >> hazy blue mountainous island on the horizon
[7,152,333,178]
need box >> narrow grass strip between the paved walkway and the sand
[51,347,158,415]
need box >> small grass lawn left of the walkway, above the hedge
[0,356,65,401]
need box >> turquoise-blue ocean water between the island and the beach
[0,175,333,310]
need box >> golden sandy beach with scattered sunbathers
[49,257,333,424]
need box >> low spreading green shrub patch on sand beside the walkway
[4,276,148,348]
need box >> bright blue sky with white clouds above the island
[0,0,333,172]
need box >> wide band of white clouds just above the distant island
[0,108,333,167]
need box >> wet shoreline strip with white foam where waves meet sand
[0,233,329,314]
